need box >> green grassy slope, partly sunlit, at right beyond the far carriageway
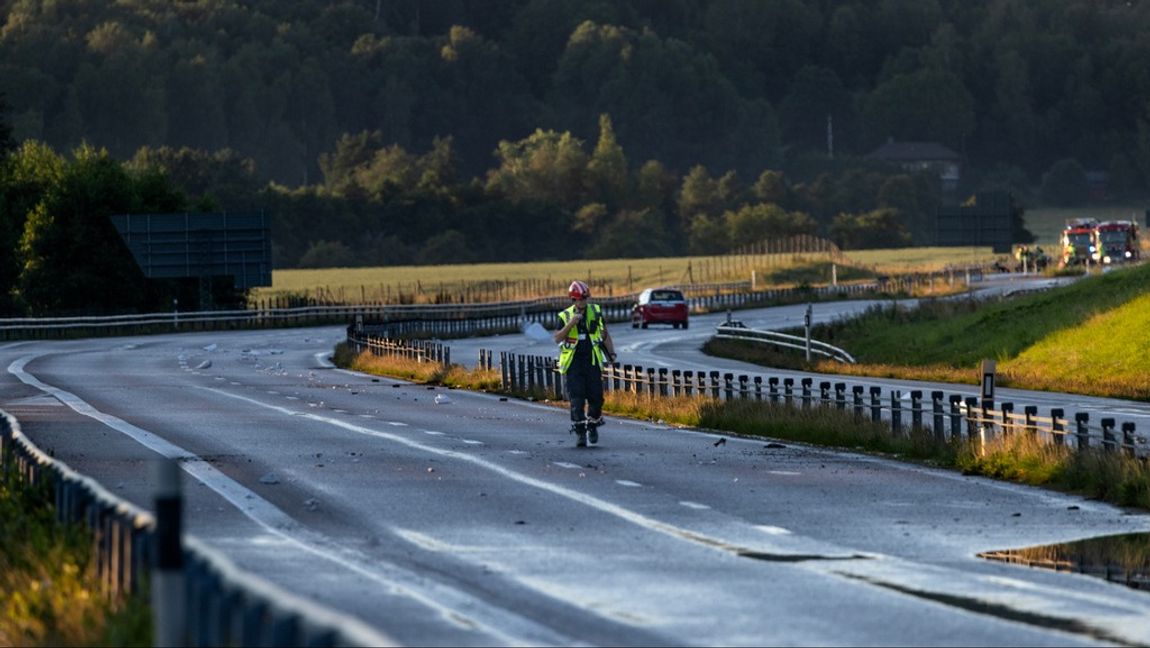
[754,265,1150,399]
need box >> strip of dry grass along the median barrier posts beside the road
[335,344,1150,510]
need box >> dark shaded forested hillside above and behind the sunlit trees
[0,0,1150,200]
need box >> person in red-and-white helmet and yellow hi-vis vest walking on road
[553,281,615,448]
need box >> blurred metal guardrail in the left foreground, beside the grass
[0,410,394,648]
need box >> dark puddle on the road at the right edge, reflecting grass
[979,533,1150,590]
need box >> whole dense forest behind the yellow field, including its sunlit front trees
[0,0,1150,310]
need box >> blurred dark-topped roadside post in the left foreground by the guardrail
[152,458,187,646]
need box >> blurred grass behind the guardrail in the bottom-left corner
[0,464,152,646]
